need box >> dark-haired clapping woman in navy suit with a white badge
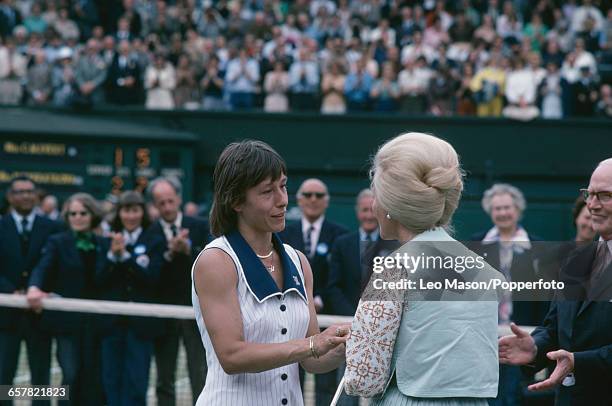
[96,191,164,406]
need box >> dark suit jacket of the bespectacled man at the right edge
[532,244,612,406]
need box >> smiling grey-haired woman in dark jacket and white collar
[472,183,546,406]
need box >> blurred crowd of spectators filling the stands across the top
[0,0,612,119]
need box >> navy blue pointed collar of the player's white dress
[225,231,308,303]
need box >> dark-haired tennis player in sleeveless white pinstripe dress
[192,141,349,406]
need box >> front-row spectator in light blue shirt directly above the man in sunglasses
[289,48,319,110]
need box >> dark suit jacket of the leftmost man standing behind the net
[0,214,62,328]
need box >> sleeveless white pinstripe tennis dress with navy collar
[191,232,310,406]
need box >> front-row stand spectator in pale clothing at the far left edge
[0,37,28,105]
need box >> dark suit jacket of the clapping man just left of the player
[149,215,210,306]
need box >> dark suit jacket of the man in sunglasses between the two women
[280,219,348,313]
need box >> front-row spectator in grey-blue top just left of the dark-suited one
[75,39,107,107]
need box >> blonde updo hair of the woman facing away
[370,133,463,234]
